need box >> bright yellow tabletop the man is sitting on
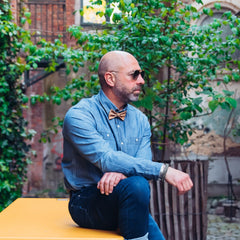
[0,198,123,240]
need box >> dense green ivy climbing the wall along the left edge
[0,1,34,211]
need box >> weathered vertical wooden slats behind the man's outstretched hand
[150,161,208,240]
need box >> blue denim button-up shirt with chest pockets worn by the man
[62,90,162,190]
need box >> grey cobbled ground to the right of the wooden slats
[207,199,240,240]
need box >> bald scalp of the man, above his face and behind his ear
[98,51,135,87]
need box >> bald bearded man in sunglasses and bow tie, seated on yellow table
[62,51,193,240]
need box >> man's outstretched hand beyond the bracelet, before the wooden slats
[165,167,193,194]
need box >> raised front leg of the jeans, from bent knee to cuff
[116,176,150,239]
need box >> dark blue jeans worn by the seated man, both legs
[69,176,164,240]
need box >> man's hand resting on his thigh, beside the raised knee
[97,172,127,195]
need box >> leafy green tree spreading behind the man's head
[31,0,240,148]
